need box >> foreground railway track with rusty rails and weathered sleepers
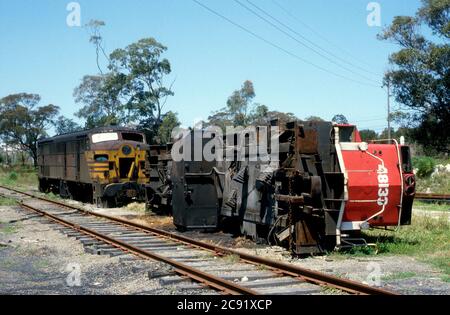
[0,186,396,295]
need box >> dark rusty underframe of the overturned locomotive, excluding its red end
[148,122,344,254]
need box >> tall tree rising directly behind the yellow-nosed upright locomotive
[74,34,173,142]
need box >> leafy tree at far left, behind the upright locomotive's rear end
[0,93,59,165]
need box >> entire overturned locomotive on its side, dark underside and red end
[148,121,415,255]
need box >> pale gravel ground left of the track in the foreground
[0,207,211,295]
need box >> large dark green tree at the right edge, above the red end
[379,0,450,153]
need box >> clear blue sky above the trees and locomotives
[0,0,420,131]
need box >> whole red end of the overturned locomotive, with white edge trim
[335,125,415,245]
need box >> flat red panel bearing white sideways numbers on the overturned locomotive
[342,143,403,226]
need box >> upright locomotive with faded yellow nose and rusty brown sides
[38,127,149,207]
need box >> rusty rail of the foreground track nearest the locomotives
[0,185,398,295]
